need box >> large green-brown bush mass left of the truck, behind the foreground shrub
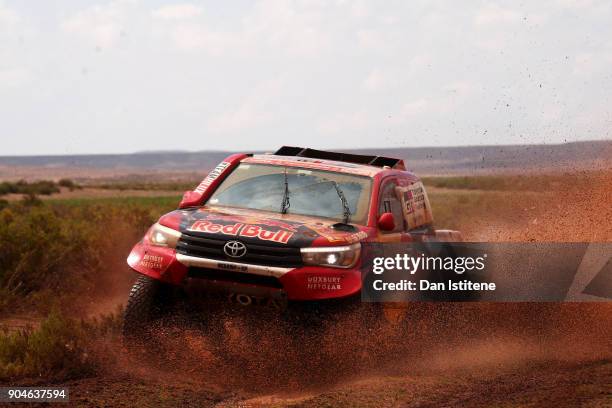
[0,201,170,312]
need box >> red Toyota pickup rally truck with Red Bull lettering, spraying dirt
[124,146,460,334]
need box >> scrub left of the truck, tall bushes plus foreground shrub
[0,197,177,382]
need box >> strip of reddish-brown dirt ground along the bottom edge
[56,362,612,407]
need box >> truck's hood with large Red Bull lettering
[159,207,369,248]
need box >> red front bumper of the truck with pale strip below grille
[128,242,362,300]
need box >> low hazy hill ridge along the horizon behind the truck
[0,141,612,178]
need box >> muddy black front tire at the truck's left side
[123,275,171,341]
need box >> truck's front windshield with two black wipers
[207,163,372,224]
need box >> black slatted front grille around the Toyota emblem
[176,231,302,268]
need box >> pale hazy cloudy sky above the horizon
[0,0,612,155]
